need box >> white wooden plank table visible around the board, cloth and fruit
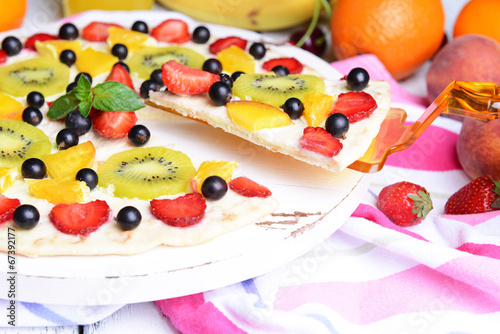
[5,0,468,334]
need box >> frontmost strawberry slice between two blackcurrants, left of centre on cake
[49,200,111,236]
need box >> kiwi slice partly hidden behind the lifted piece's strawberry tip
[127,46,205,79]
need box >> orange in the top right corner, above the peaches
[453,0,500,42]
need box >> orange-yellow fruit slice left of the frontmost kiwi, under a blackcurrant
[42,141,95,181]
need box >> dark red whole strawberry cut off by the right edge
[444,175,500,215]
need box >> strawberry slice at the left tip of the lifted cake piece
[161,60,220,95]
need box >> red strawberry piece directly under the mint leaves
[92,110,137,138]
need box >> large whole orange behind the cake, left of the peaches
[330,0,444,80]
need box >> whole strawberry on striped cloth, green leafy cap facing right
[377,181,432,227]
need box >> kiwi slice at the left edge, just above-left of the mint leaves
[0,57,69,97]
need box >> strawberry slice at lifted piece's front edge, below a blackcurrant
[300,126,343,158]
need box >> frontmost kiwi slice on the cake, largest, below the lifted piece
[97,146,196,200]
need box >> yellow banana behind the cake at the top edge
[157,0,317,31]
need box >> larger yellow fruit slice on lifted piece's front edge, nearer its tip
[226,100,293,131]
